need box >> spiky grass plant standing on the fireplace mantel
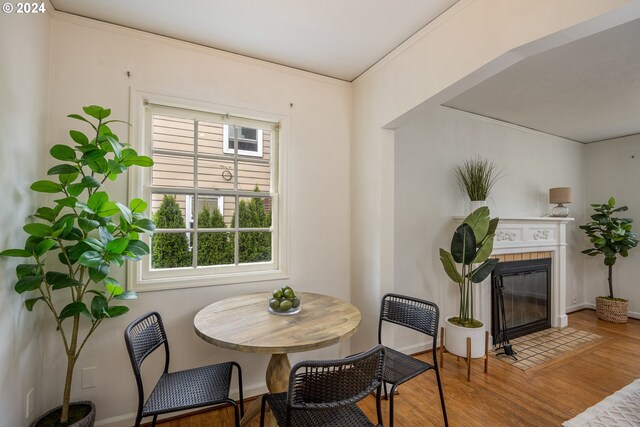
[455,157,500,201]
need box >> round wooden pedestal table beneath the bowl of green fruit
[193,292,361,424]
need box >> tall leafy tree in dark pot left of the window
[0,105,155,426]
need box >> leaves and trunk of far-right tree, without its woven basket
[580,197,638,299]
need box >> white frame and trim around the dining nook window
[127,90,290,292]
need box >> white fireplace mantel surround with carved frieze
[455,217,574,338]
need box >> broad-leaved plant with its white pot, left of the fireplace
[440,206,499,358]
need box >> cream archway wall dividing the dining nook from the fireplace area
[351,0,640,350]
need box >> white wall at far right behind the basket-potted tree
[583,135,640,318]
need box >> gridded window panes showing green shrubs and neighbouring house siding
[132,104,282,290]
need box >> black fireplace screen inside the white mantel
[491,258,551,342]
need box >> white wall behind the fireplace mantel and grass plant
[394,107,585,351]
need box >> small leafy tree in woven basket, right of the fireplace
[580,197,638,323]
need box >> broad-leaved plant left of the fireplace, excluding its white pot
[440,206,499,328]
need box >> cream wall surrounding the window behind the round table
[38,14,351,425]
